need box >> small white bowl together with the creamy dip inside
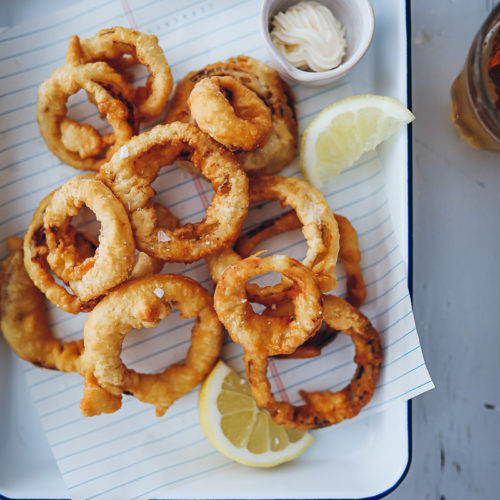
[260,0,375,86]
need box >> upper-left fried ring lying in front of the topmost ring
[37,62,139,170]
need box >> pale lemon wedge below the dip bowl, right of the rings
[300,95,415,188]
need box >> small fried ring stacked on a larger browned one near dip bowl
[165,56,298,175]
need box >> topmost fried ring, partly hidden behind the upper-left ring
[66,26,173,120]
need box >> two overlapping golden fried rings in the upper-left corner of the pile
[37,26,172,170]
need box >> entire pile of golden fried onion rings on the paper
[0,27,382,438]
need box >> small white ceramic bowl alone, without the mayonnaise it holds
[260,0,375,86]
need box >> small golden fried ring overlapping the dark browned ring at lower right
[214,255,322,356]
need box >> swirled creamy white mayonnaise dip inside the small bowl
[271,1,346,71]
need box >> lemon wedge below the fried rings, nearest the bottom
[198,361,314,467]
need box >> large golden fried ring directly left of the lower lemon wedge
[80,274,223,416]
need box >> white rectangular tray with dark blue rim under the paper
[0,0,411,499]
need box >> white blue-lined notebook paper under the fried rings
[0,0,433,499]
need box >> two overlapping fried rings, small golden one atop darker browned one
[215,255,382,429]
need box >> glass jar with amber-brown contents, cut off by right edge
[451,4,500,153]
